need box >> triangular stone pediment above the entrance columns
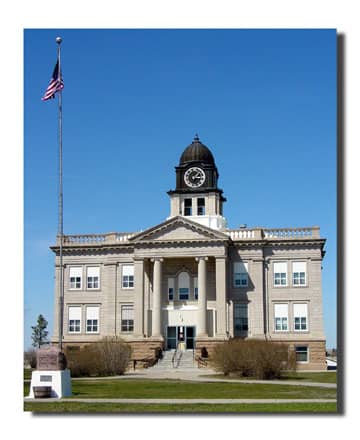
[129,217,229,243]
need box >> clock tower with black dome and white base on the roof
[168,135,226,230]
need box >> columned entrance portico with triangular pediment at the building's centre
[129,217,229,348]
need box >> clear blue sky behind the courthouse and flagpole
[24,29,336,347]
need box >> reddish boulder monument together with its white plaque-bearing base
[28,346,72,398]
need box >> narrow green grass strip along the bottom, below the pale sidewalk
[24,401,337,414]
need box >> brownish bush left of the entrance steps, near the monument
[66,337,131,377]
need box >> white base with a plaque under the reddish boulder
[28,369,72,399]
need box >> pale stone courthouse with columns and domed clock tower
[52,136,326,369]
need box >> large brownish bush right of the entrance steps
[212,339,296,379]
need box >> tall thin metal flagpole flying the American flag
[56,37,64,351]
